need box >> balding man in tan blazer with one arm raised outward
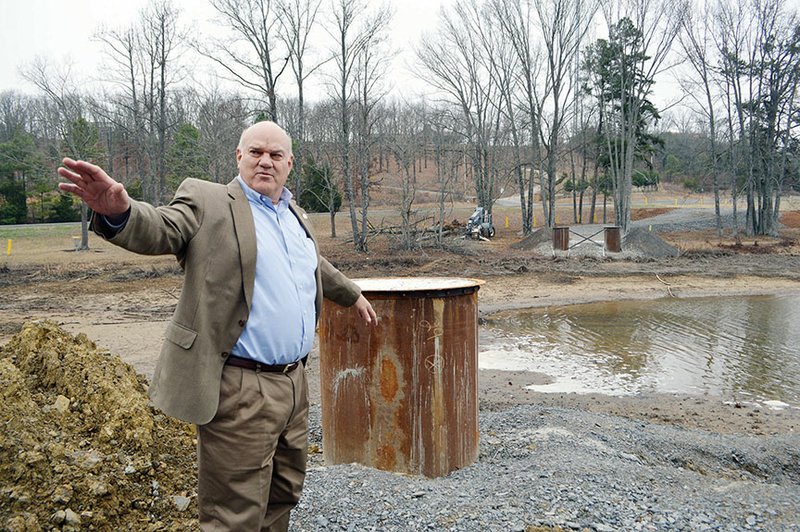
[58,122,376,530]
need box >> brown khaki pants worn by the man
[197,366,308,532]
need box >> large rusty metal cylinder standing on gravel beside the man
[320,277,481,477]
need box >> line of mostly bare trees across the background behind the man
[0,0,800,251]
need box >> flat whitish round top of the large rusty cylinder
[353,277,484,297]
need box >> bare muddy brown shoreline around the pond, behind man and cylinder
[0,250,800,435]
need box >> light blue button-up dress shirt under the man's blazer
[231,177,317,364]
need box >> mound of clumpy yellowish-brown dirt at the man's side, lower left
[0,321,196,530]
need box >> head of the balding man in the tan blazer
[236,122,294,203]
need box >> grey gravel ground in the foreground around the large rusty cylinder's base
[292,405,800,531]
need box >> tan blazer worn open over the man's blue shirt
[92,179,361,425]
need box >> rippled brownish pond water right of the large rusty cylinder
[480,294,800,405]
